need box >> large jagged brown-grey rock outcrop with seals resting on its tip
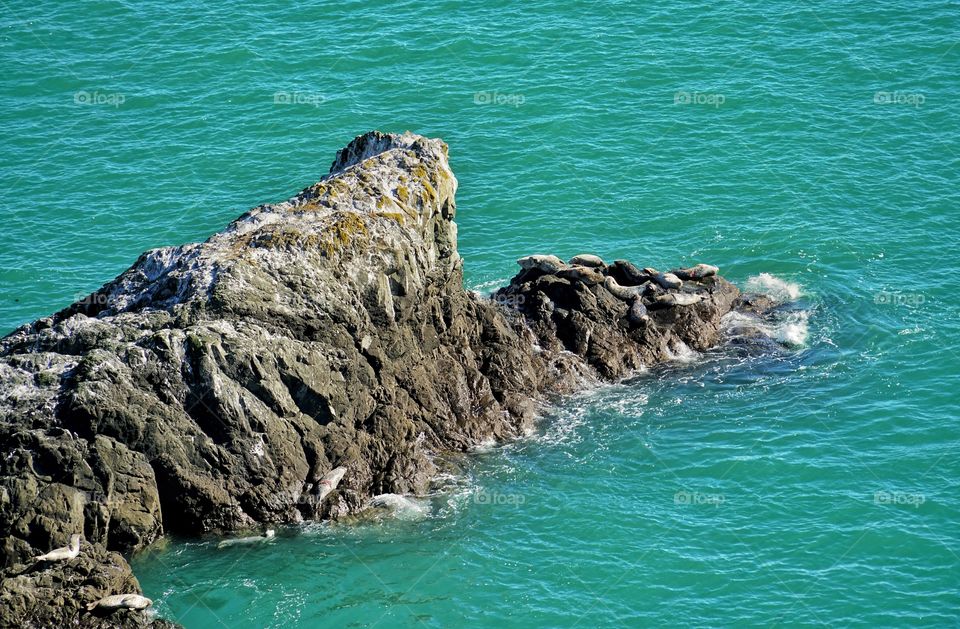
[0,132,756,624]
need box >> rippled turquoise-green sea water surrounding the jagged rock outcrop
[0,0,960,629]
